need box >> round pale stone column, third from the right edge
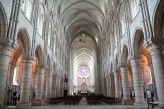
[121,65,130,103]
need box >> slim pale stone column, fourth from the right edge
[114,71,121,98]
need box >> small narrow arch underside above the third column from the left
[35,44,43,66]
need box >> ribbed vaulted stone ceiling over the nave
[57,0,109,44]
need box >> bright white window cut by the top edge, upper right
[130,0,139,20]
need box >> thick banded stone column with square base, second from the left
[17,57,33,107]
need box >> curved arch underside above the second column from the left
[15,28,31,56]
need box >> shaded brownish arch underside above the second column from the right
[132,29,144,57]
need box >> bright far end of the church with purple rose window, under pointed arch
[70,34,97,94]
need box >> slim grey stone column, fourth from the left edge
[46,70,53,98]
